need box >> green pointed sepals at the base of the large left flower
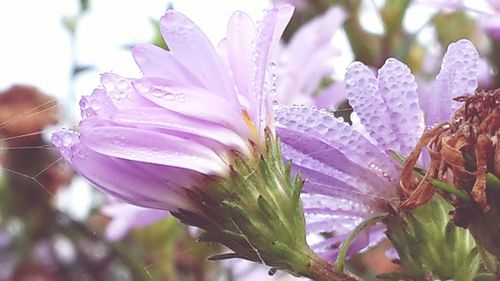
[168,130,336,280]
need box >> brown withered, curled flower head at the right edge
[400,89,500,214]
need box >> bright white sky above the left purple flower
[0,0,269,114]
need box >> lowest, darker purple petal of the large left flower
[52,131,200,210]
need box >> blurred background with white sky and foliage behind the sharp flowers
[0,0,500,281]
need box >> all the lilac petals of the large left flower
[52,6,293,210]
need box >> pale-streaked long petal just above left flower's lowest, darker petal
[80,119,227,175]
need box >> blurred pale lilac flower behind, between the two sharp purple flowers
[276,7,346,108]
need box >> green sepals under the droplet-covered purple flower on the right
[384,196,479,281]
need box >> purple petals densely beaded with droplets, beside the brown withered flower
[276,40,479,259]
